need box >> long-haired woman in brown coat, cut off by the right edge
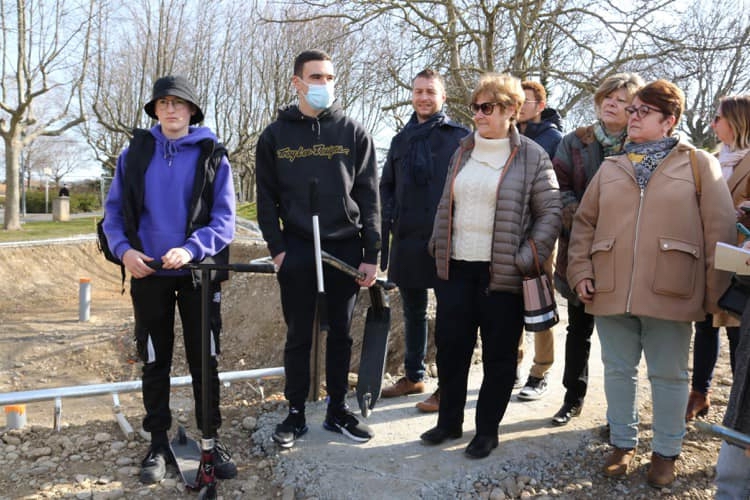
[685,95,750,420]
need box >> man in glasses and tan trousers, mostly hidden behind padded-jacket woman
[517,80,562,401]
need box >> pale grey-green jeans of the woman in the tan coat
[595,314,692,457]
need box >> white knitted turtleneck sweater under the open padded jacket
[451,132,510,262]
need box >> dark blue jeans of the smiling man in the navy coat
[399,287,429,382]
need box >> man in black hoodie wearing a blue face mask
[256,50,380,448]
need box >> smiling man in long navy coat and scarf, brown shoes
[380,69,469,412]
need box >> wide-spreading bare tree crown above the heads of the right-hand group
[268,0,704,129]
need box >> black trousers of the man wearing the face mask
[276,232,362,410]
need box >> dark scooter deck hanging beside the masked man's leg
[357,286,391,418]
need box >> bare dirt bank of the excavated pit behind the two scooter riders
[0,238,412,402]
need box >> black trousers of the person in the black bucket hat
[130,276,221,433]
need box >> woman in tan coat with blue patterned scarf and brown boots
[568,80,736,488]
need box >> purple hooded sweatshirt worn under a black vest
[104,125,235,275]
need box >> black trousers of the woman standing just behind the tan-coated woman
[563,300,594,405]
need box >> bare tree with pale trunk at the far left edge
[0,0,95,230]
